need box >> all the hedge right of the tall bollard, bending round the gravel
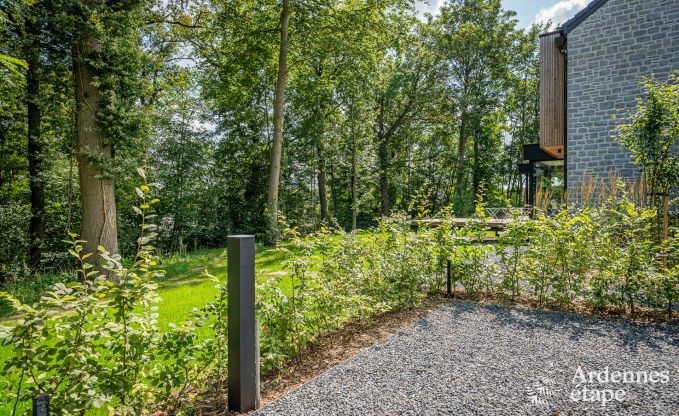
[257,187,679,380]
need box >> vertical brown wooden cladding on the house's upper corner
[540,33,566,159]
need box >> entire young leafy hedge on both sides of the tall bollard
[0,185,679,415]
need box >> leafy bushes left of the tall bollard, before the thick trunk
[0,178,213,415]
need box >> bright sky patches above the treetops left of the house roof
[418,0,591,27]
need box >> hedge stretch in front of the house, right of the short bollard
[450,189,679,313]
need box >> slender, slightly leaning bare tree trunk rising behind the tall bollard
[268,0,291,234]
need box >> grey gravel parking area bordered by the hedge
[255,303,679,416]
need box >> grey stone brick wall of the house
[566,0,679,193]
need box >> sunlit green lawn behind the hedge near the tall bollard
[0,244,293,414]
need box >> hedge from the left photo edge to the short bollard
[0,202,450,415]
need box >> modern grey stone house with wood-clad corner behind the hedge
[520,0,679,205]
